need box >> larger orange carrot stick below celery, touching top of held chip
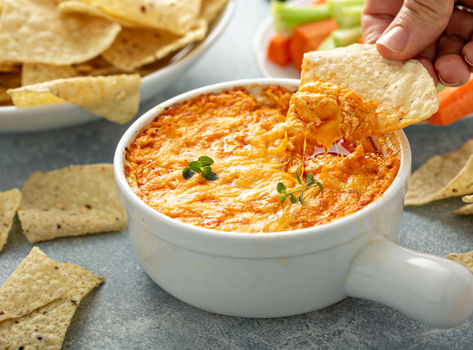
[289,18,338,71]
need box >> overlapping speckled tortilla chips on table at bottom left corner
[0,247,104,349]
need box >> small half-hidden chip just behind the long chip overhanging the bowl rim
[21,63,79,86]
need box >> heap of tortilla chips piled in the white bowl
[0,0,228,123]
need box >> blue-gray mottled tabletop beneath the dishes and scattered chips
[0,0,473,349]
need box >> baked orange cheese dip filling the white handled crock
[125,87,400,232]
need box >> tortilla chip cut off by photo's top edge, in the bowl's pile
[56,0,201,35]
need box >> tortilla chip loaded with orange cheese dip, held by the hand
[298,44,438,147]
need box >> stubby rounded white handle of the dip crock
[345,237,473,328]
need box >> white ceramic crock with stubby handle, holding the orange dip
[114,79,473,328]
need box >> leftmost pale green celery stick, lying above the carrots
[271,1,330,33]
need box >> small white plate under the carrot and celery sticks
[253,0,313,79]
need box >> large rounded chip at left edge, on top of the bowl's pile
[0,0,121,65]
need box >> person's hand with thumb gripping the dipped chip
[362,0,473,86]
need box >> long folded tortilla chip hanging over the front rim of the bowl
[7,74,141,123]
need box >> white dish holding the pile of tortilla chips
[0,0,236,132]
